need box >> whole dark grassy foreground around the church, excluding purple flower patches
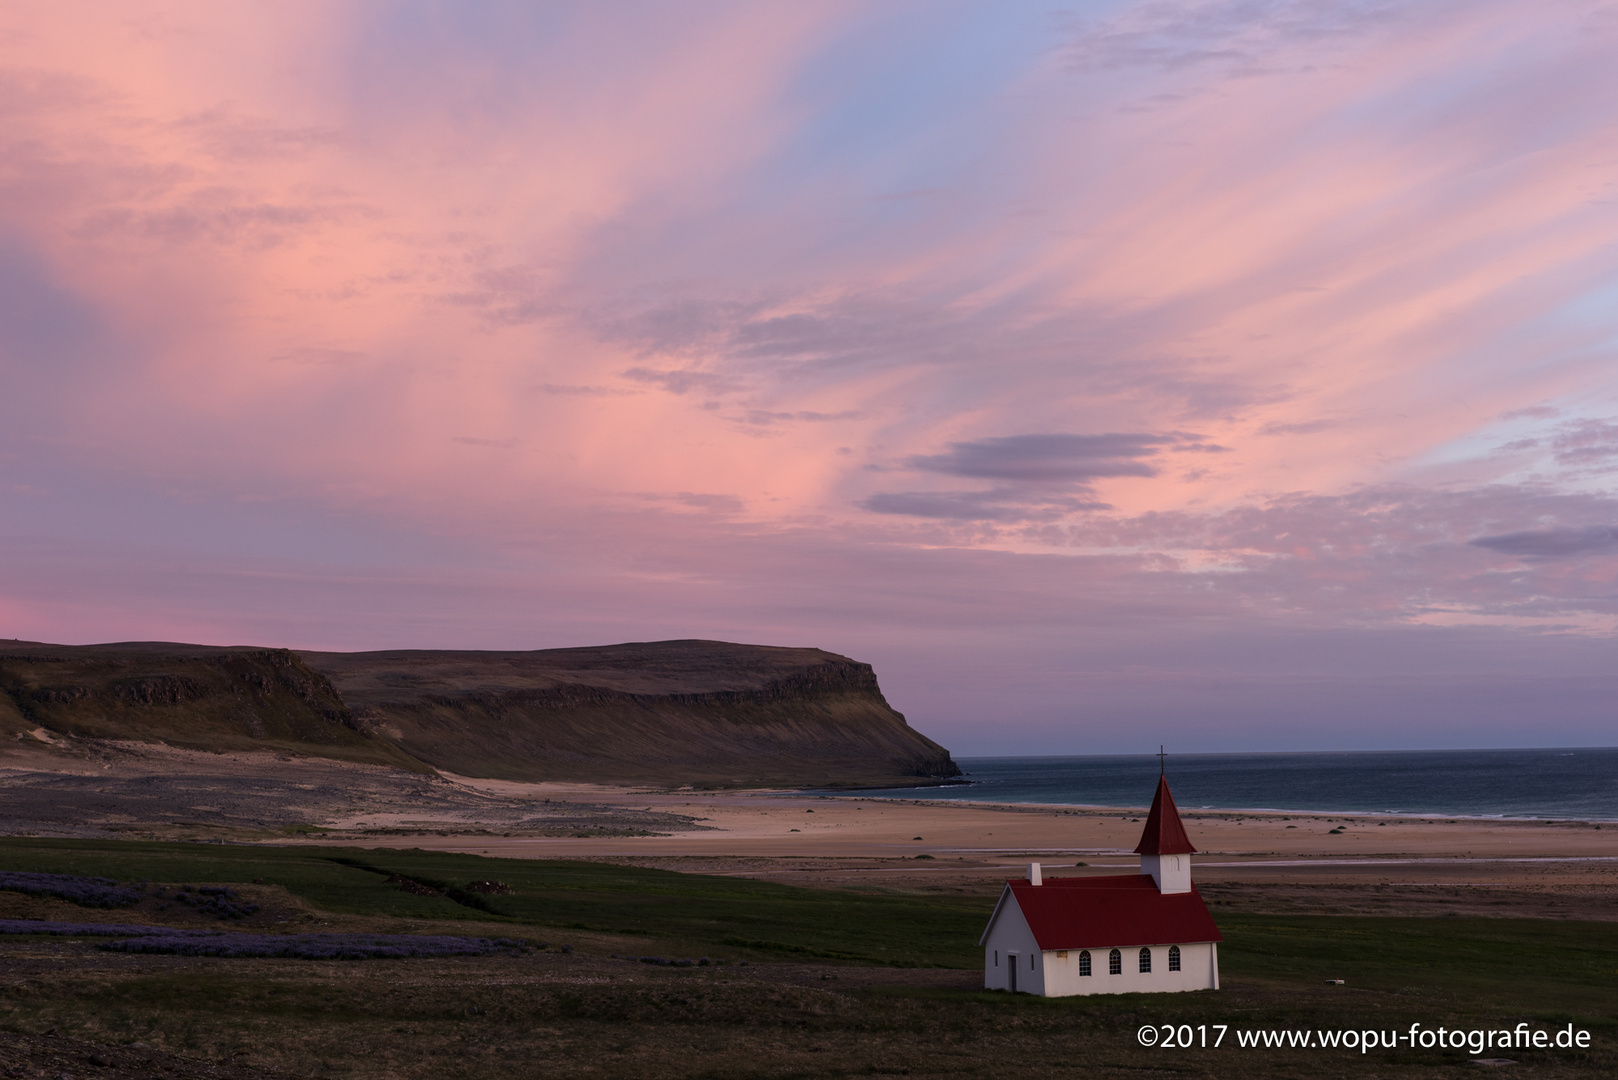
[0,840,1618,1080]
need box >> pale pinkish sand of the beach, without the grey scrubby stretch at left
[297,777,1618,918]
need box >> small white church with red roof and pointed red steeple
[979,776,1223,997]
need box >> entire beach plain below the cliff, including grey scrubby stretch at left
[0,743,1618,920]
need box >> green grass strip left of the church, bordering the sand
[0,839,985,968]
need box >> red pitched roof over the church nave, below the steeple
[984,874,1225,949]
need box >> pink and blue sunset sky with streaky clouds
[0,0,1618,756]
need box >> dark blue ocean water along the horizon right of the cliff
[834,746,1618,821]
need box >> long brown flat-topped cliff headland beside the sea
[0,641,959,787]
